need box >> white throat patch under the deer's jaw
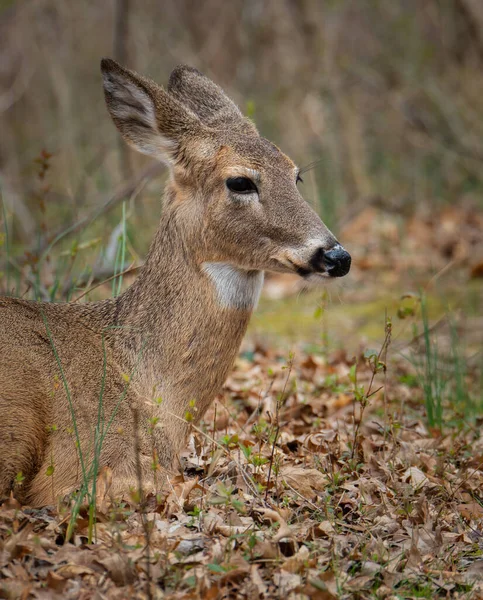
[202,263,263,310]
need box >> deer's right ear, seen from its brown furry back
[168,65,257,133]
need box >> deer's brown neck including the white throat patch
[110,212,263,415]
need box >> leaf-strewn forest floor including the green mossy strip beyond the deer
[0,203,483,600]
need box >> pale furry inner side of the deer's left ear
[104,72,176,161]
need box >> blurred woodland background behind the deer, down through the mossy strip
[0,0,483,365]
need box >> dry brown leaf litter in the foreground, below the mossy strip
[0,344,483,600]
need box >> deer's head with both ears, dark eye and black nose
[101,59,351,290]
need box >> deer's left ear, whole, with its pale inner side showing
[101,58,203,163]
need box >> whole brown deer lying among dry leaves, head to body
[0,59,351,506]
